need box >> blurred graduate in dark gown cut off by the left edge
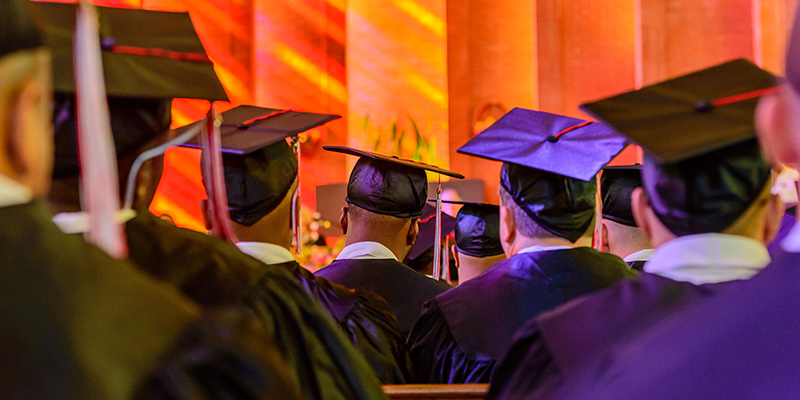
[0,0,300,399]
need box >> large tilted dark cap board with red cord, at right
[581,59,776,163]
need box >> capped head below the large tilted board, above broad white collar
[634,140,782,243]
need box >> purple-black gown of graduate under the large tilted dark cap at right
[488,273,740,399]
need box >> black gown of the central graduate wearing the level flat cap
[315,259,447,334]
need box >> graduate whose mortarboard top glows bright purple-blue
[408,108,635,383]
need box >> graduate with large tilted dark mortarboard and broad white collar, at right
[489,60,783,399]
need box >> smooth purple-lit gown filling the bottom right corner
[544,247,800,400]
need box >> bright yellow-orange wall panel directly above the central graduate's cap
[346,0,449,178]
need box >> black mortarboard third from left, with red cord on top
[175,106,340,226]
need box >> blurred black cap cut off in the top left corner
[0,0,42,57]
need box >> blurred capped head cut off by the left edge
[0,0,53,195]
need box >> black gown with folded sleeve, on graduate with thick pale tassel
[125,212,385,399]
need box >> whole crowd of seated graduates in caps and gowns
[0,0,800,400]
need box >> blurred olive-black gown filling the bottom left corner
[0,202,297,399]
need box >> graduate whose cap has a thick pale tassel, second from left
[41,3,383,399]
